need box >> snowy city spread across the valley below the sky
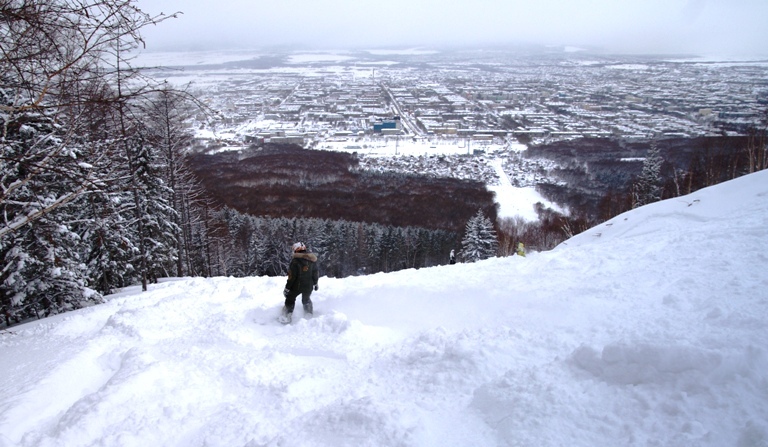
[136,47,768,217]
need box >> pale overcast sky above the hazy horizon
[138,0,768,56]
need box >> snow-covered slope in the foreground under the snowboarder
[0,171,768,447]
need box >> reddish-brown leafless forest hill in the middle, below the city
[190,145,497,234]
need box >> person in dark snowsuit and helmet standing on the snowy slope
[280,242,319,324]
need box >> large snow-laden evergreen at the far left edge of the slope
[0,89,106,323]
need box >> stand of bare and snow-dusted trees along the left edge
[0,0,219,324]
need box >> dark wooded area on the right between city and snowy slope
[526,136,749,220]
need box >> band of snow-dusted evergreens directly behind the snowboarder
[217,208,460,278]
